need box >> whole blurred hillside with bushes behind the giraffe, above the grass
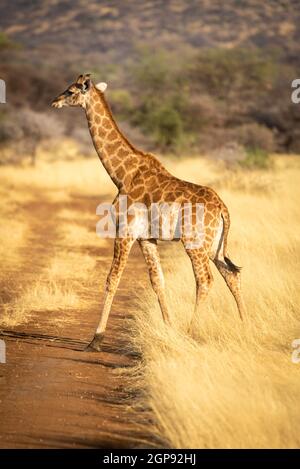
[0,0,300,158]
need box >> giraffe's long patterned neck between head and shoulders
[85,87,142,190]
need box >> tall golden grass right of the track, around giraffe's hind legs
[135,158,300,448]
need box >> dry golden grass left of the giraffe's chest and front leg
[0,160,112,328]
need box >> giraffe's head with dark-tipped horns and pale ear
[52,74,107,108]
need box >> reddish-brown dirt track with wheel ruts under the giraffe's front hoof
[0,186,155,448]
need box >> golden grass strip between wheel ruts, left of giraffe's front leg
[0,249,95,327]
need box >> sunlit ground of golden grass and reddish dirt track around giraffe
[0,155,300,448]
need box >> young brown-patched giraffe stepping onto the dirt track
[52,74,245,350]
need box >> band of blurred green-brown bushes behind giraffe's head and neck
[0,41,300,154]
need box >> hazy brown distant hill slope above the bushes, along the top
[0,0,300,63]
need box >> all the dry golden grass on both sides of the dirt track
[0,157,300,448]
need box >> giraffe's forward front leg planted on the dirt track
[86,238,134,351]
